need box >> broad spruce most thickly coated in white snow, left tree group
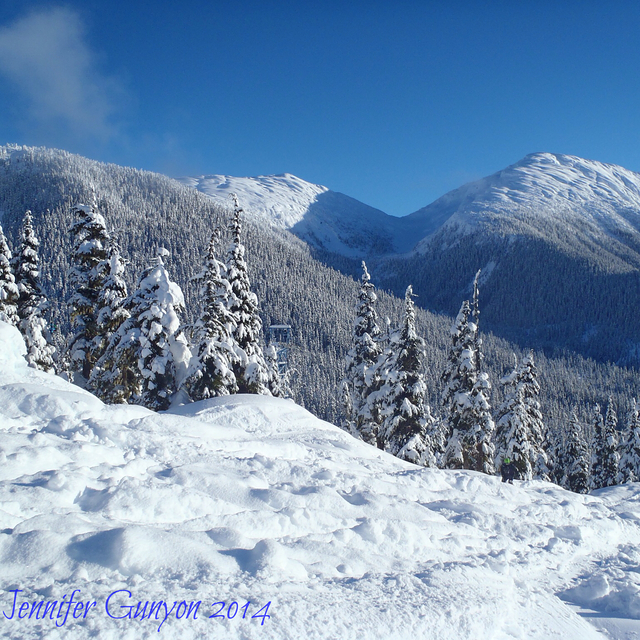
[104,257,191,411]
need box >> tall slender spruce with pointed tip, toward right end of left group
[227,194,271,395]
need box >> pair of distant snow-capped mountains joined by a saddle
[182,153,640,367]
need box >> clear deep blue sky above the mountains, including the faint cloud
[0,0,640,215]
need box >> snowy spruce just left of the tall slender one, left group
[184,228,242,400]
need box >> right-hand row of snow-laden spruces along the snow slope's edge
[342,262,640,493]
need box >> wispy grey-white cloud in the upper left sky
[0,7,123,143]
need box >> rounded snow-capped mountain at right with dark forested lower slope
[372,153,640,367]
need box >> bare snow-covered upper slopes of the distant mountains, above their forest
[179,153,640,257]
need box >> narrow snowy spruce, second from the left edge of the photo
[14,211,55,373]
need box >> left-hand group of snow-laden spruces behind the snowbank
[0,196,289,410]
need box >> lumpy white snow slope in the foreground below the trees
[0,323,640,640]
